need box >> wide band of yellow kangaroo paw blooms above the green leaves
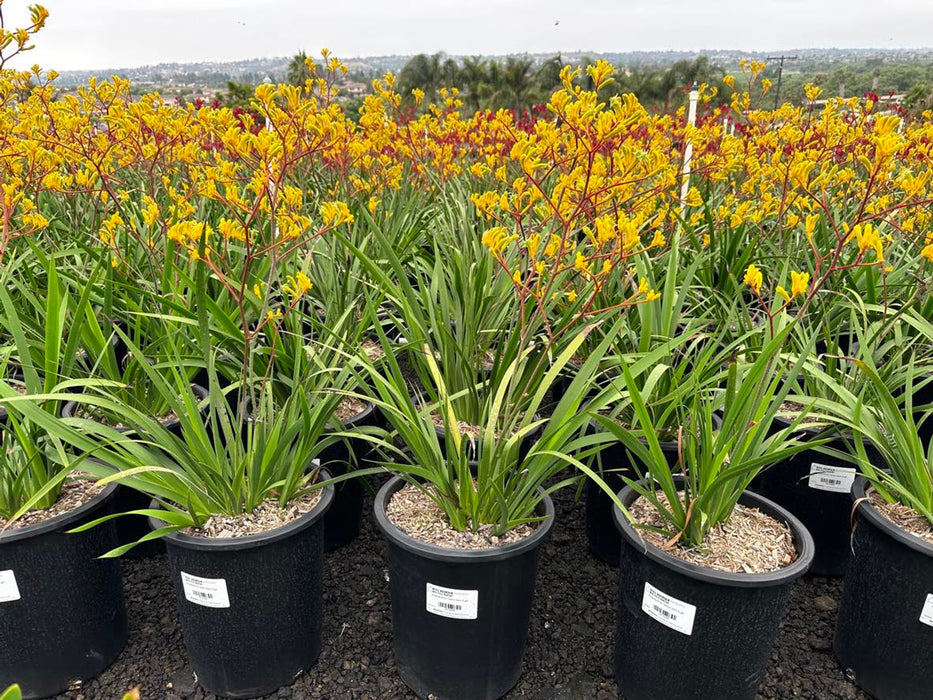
[0,41,933,328]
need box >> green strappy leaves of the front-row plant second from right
[591,326,814,547]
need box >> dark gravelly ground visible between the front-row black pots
[51,482,867,700]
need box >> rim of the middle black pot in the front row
[373,476,554,563]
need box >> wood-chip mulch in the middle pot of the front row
[386,484,535,550]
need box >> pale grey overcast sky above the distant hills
[3,0,933,70]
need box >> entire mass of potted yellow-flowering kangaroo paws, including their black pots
[0,18,933,698]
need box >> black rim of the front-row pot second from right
[612,477,816,588]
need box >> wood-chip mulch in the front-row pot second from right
[629,492,797,574]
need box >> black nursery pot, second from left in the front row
[150,473,334,698]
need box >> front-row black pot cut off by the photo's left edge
[0,485,127,698]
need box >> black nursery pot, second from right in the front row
[615,487,813,700]
